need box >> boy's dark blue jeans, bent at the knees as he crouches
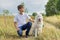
[17,22,32,36]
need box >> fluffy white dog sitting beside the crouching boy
[33,14,43,37]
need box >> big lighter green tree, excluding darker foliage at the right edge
[46,0,57,16]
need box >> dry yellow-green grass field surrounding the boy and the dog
[0,16,60,40]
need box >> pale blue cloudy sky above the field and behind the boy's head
[0,0,48,13]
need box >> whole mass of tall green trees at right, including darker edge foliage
[45,0,60,16]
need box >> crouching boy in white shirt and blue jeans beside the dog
[14,5,33,37]
